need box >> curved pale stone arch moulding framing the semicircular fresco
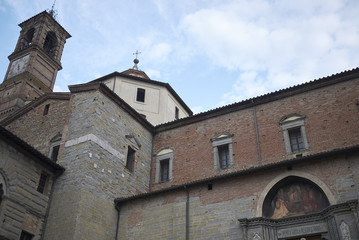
[256,171,337,217]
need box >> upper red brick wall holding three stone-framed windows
[152,79,359,189]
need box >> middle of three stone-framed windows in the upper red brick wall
[211,132,233,170]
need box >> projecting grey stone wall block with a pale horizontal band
[45,88,152,239]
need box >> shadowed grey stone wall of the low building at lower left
[0,137,57,240]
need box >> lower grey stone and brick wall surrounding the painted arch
[119,155,359,239]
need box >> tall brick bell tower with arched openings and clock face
[0,10,71,120]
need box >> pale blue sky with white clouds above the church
[0,0,359,113]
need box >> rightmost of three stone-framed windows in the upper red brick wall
[279,113,309,155]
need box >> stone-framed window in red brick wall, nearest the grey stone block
[155,148,173,183]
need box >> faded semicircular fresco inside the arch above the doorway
[262,176,329,219]
